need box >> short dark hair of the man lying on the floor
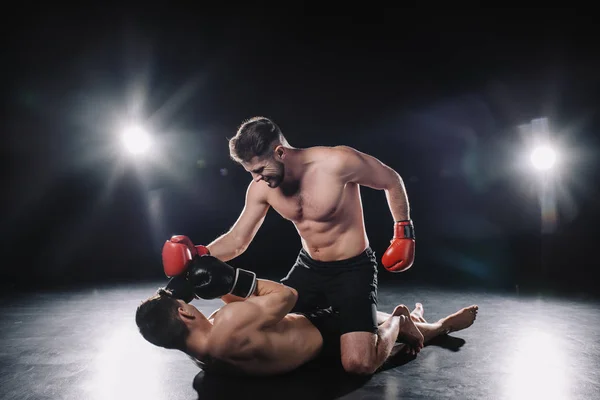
[135,289,190,350]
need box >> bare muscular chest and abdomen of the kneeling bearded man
[265,148,369,261]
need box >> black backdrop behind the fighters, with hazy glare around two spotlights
[0,7,600,293]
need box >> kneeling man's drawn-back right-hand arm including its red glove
[332,146,415,272]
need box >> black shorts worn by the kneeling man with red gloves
[281,247,377,335]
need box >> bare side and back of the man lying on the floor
[195,314,323,375]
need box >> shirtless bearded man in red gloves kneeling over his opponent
[165,117,415,374]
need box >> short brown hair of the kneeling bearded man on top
[229,117,287,163]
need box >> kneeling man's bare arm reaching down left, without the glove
[207,181,269,261]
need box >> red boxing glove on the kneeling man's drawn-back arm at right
[381,220,415,272]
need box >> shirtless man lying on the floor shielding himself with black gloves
[136,255,477,375]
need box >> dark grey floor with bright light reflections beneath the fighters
[0,283,600,400]
